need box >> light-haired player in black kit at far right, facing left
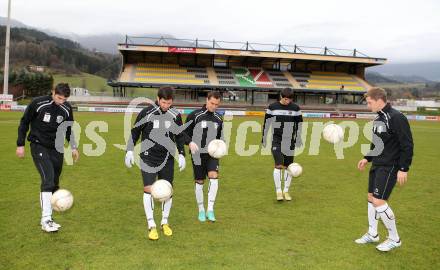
[355,87,414,252]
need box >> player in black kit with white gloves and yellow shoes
[125,87,185,240]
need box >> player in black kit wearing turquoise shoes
[185,91,223,222]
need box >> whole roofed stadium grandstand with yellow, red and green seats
[109,36,386,106]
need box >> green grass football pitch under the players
[0,112,440,270]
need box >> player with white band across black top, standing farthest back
[262,88,303,201]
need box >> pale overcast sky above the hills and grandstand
[0,0,440,63]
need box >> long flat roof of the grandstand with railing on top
[118,36,386,67]
